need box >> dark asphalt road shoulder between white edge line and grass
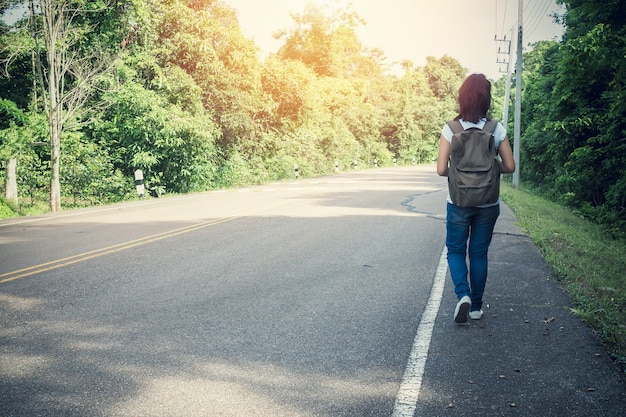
[415,204,626,417]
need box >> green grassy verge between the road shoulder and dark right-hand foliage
[501,184,626,369]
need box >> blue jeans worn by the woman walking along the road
[446,203,500,311]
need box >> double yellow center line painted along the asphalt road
[0,202,296,284]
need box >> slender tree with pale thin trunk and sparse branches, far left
[30,0,117,212]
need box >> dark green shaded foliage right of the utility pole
[521,0,626,237]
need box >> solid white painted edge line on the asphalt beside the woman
[392,246,448,417]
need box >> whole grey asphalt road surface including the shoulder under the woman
[0,167,626,417]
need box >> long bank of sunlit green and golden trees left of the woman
[0,0,466,210]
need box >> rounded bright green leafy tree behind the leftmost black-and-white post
[89,80,219,192]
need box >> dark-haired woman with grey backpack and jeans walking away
[437,74,515,324]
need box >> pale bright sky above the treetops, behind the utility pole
[223,0,563,79]
